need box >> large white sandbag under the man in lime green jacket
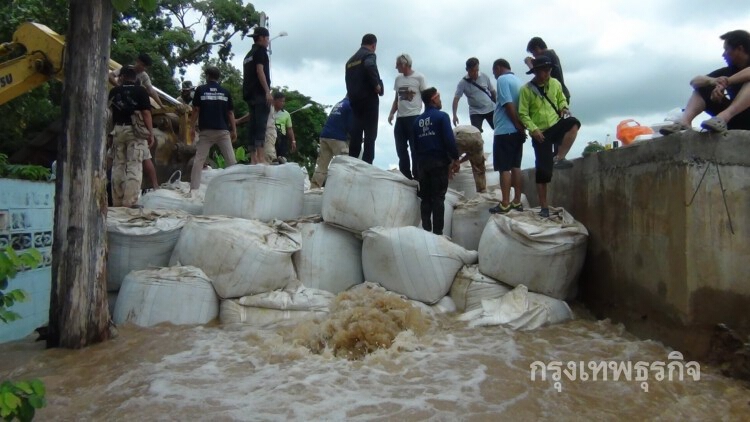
[479,208,588,299]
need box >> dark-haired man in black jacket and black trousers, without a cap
[345,34,383,164]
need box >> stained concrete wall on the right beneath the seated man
[524,131,750,358]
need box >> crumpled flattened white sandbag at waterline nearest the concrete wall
[459,284,573,331]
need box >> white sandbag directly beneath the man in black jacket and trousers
[322,155,420,232]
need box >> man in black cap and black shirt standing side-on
[242,27,273,164]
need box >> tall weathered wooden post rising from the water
[47,0,112,349]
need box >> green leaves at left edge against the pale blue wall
[0,246,42,323]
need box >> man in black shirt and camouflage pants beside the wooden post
[109,66,154,207]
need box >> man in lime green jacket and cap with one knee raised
[518,56,581,217]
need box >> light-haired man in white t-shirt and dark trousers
[388,53,427,179]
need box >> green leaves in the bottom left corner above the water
[0,379,47,421]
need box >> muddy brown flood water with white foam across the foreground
[0,302,750,421]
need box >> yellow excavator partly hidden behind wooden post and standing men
[0,22,195,182]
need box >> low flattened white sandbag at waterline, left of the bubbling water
[219,299,328,327]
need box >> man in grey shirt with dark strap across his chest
[453,57,496,132]
